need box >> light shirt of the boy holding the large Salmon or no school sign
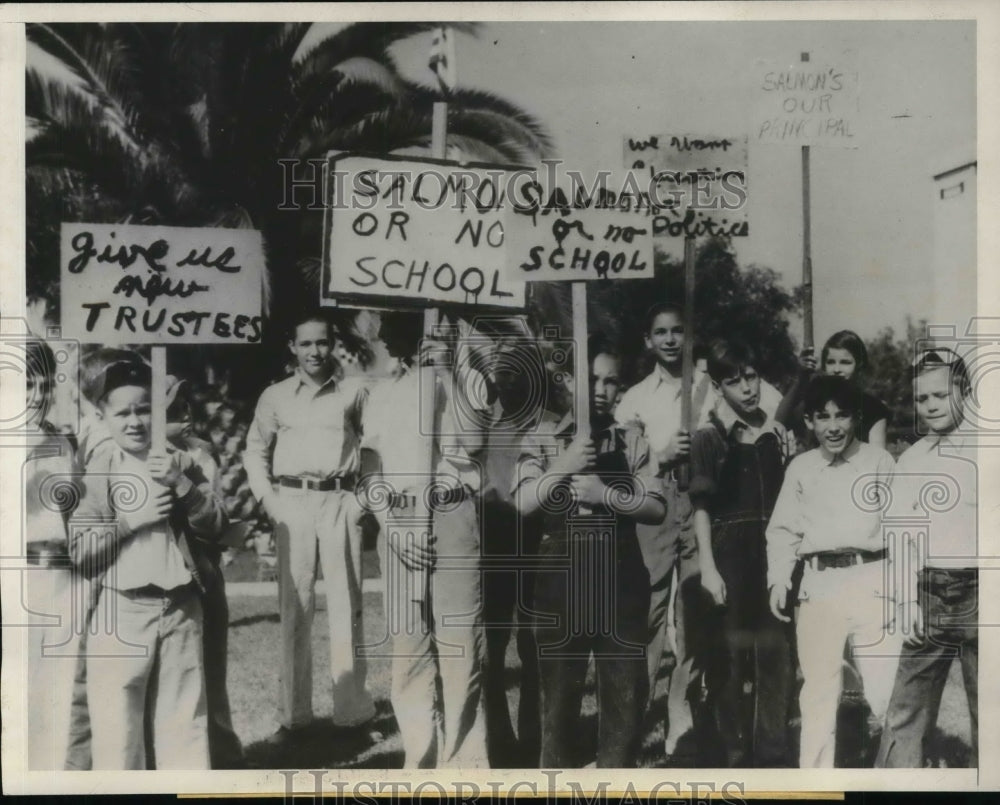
[361,366,489,495]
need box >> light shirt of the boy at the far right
[889,433,979,569]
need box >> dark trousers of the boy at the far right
[875,568,979,768]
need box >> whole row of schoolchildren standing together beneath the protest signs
[19,305,978,769]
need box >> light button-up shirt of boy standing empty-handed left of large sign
[243,370,365,500]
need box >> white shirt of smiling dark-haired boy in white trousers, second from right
[767,440,895,587]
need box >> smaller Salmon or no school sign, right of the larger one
[506,190,653,282]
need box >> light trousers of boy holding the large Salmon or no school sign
[381,500,489,769]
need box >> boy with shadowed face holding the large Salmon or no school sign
[360,312,488,769]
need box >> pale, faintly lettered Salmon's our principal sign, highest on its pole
[750,51,858,148]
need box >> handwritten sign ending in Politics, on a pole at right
[624,134,749,238]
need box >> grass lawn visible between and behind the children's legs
[223,552,970,769]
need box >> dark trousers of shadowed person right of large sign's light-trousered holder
[483,502,541,769]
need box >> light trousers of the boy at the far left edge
[23,566,90,770]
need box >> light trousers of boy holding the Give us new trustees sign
[87,586,209,770]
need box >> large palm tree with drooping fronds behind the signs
[26,22,551,334]
